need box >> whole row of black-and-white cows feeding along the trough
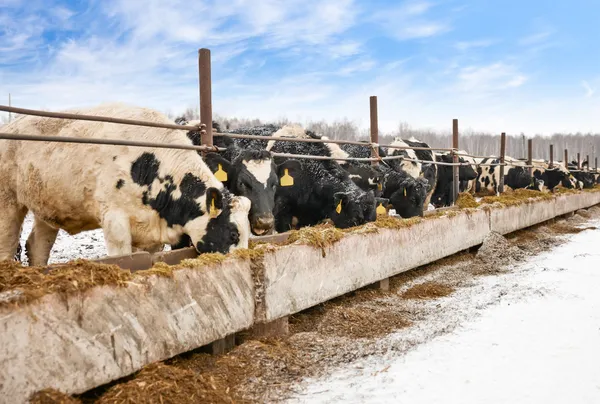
[0,104,598,265]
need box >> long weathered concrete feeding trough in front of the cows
[0,192,600,403]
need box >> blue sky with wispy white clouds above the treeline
[0,0,600,134]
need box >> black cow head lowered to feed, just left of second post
[330,191,377,229]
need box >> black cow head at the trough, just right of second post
[383,171,428,218]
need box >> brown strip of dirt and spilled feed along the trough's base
[41,207,600,404]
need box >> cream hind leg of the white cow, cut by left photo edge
[0,200,27,261]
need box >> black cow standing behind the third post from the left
[431,153,477,208]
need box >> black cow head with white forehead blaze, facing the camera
[205,149,300,236]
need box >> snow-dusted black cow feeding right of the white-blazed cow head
[218,125,377,233]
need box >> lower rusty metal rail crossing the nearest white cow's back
[0,132,225,152]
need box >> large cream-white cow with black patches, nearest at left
[0,103,250,266]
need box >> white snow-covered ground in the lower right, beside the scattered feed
[288,220,600,404]
